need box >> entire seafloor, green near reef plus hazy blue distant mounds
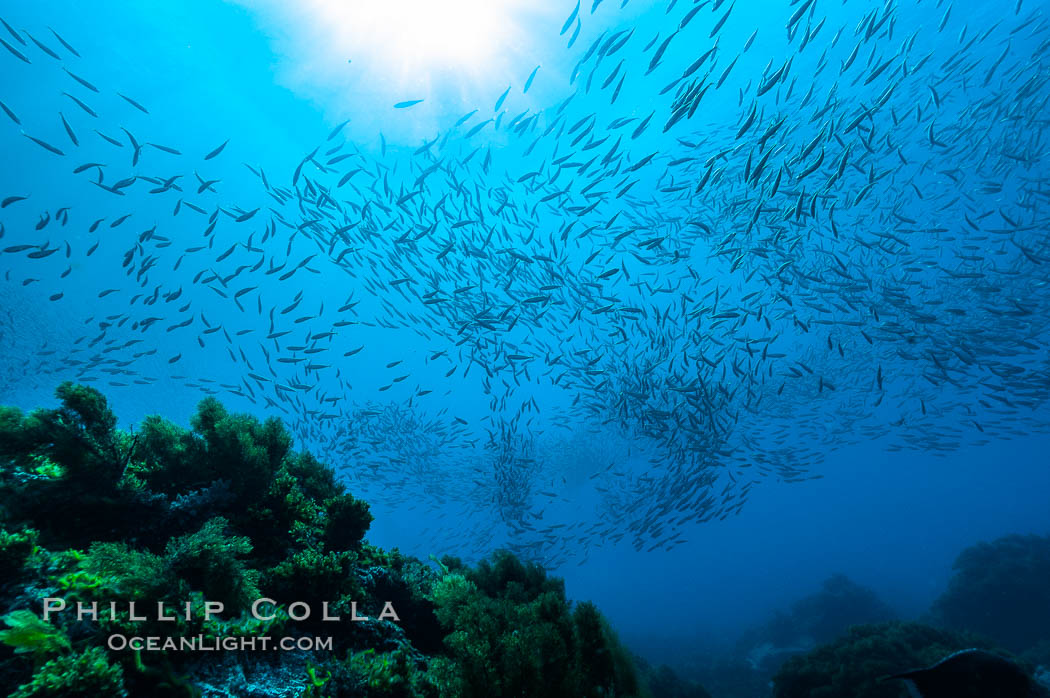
[0,383,1050,698]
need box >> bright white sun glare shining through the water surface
[236,0,561,143]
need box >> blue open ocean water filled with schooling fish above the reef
[0,0,1050,692]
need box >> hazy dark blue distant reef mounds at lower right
[674,562,1050,698]
